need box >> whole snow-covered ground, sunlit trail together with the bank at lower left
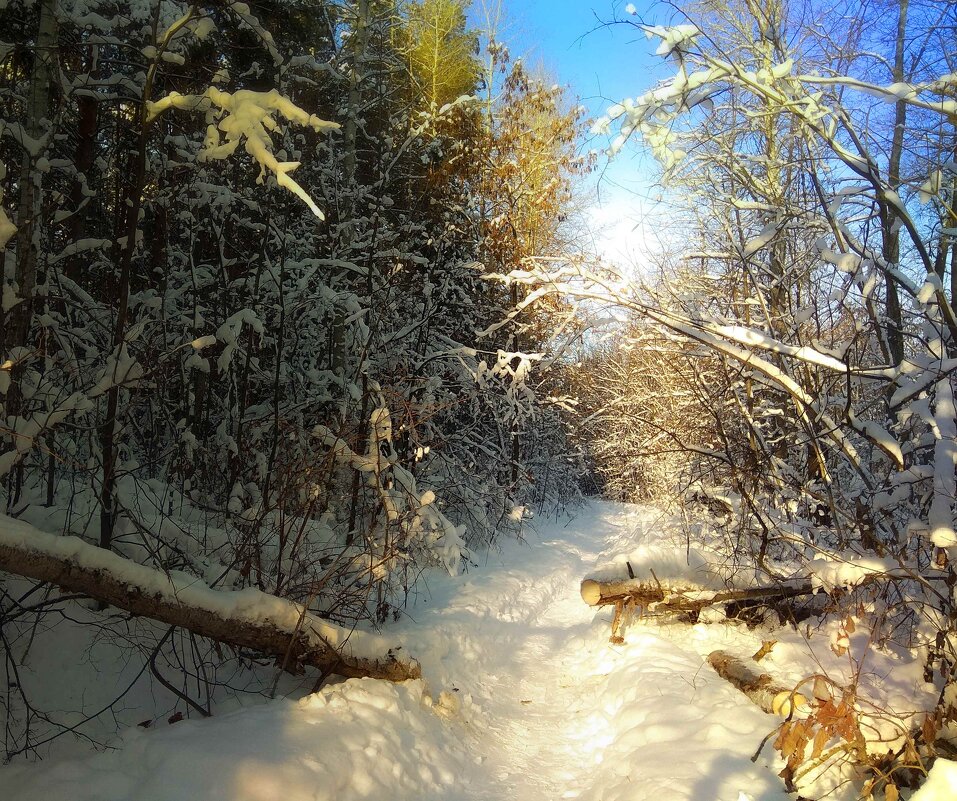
[0,503,948,801]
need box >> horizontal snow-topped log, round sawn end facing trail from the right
[581,579,814,612]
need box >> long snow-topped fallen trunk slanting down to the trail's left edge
[0,515,421,681]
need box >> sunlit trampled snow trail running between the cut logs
[412,504,787,801]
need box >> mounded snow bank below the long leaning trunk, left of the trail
[0,679,471,801]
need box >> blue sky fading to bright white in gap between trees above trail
[471,0,669,262]
